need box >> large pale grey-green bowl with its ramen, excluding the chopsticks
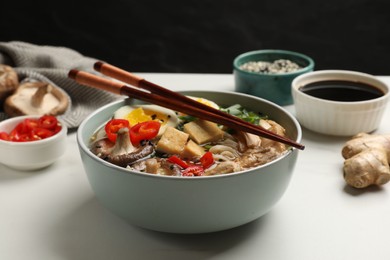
[77,91,304,233]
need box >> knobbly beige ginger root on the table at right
[341,133,390,188]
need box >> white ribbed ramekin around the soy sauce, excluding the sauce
[292,70,390,136]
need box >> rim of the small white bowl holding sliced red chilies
[0,115,68,147]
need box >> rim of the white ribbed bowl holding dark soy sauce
[291,70,390,106]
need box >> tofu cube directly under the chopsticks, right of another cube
[184,119,223,144]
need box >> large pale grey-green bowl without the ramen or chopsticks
[77,91,302,233]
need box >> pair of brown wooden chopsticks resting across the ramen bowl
[68,67,304,150]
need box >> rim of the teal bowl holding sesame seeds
[233,49,315,77]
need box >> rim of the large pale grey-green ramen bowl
[76,90,302,181]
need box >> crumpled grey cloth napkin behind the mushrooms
[0,41,121,128]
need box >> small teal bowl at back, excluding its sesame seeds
[233,50,314,106]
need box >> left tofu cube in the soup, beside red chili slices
[156,126,189,154]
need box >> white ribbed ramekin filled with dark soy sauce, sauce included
[292,70,390,136]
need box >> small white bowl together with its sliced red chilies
[0,115,67,170]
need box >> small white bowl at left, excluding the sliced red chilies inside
[0,116,68,171]
